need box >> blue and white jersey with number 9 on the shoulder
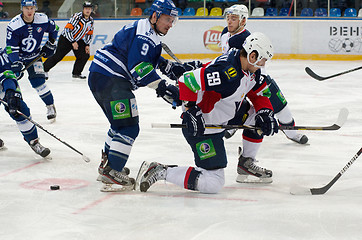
[89,19,162,89]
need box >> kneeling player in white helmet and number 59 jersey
[136,33,278,193]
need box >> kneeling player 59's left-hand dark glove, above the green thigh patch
[181,105,205,137]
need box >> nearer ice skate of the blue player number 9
[101,166,135,192]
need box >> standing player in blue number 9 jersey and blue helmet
[88,0,181,191]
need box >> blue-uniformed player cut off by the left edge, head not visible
[0,48,50,157]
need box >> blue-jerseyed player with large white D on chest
[6,0,59,122]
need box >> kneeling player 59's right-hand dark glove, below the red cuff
[255,108,278,136]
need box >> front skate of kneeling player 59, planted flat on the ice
[236,148,273,183]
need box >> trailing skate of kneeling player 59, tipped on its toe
[136,161,167,192]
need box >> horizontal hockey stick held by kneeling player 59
[152,108,348,131]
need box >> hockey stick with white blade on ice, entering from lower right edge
[290,148,362,195]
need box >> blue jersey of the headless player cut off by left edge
[0,48,18,99]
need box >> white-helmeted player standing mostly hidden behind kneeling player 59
[221,4,308,144]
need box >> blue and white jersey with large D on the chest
[6,13,59,62]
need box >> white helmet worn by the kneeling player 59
[243,32,274,67]
